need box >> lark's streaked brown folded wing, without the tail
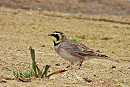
[63,40,96,57]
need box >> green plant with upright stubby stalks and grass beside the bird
[13,46,67,82]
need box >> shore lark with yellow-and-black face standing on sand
[48,31,119,69]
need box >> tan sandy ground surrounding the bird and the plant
[0,8,130,87]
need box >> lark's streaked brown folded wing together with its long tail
[63,40,119,62]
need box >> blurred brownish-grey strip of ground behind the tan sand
[0,0,130,15]
